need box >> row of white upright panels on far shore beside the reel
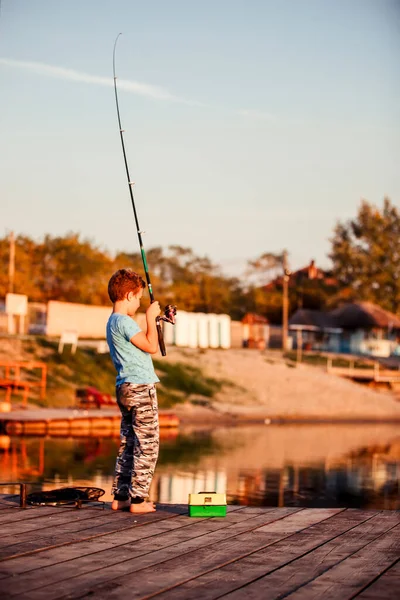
[164,310,231,348]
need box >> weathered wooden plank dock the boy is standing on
[0,495,400,600]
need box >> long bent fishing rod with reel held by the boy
[113,33,176,356]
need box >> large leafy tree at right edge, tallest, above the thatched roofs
[329,198,400,313]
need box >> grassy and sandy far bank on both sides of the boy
[0,341,400,426]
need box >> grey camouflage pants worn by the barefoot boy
[112,383,159,498]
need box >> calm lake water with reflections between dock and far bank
[0,425,400,509]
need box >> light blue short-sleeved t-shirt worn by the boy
[107,313,160,385]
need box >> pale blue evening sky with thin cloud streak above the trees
[0,0,400,275]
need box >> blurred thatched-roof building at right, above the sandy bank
[289,302,400,356]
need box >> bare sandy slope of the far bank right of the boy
[163,348,400,419]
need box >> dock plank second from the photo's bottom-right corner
[287,525,400,600]
